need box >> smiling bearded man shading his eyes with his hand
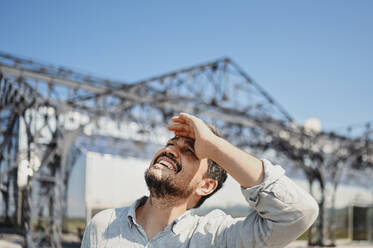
[82,113,318,248]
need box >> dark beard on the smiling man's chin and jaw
[145,168,193,199]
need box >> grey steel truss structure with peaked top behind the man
[0,53,373,247]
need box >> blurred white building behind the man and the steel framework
[19,109,373,223]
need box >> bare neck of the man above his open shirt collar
[136,196,188,240]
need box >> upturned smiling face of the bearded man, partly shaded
[145,136,208,198]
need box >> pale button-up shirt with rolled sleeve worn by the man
[81,160,318,248]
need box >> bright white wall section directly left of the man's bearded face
[85,152,150,222]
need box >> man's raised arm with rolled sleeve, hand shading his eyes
[169,113,318,247]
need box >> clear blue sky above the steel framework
[0,0,373,133]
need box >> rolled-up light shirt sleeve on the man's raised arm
[216,160,318,248]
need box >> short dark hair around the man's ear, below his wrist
[193,125,227,208]
